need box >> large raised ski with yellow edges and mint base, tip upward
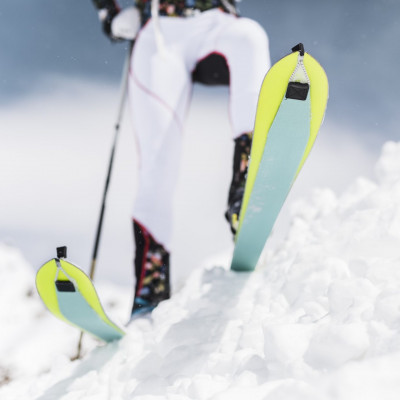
[231,43,328,271]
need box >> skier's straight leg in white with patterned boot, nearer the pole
[129,24,191,314]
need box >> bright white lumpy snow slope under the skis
[0,142,400,400]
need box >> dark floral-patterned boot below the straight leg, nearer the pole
[131,221,170,319]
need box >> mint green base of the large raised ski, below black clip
[231,95,310,271]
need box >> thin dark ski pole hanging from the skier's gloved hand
[75,41,134,359]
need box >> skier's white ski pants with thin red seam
[129,9,270,249]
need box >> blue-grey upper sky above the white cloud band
[0,0,400,141]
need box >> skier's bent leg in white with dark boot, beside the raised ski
[211,16,270,233]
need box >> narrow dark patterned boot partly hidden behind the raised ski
[225,132,253,235]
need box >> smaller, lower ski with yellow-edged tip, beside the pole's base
[36,247,125,343]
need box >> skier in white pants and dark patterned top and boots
[92,0,270,317]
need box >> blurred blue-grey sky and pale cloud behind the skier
[0,0,400,288]
